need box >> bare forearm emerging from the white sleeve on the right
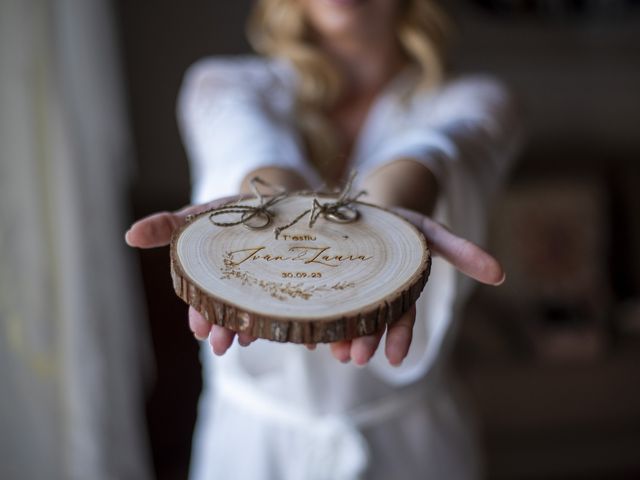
[363,158,438,215]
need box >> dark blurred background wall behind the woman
[113,0,640,479]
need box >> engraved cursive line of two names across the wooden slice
[229,246,373,267]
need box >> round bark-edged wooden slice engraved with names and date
[171,194,431,343]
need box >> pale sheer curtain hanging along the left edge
[0,0,150,480]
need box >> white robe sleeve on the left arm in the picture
[178,59,313,203]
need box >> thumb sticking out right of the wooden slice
[395,208,505,285]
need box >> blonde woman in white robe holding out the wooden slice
[127,0,517,480]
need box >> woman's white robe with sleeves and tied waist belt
[178,57,519,480]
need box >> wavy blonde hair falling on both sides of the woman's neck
[247,0,450,178]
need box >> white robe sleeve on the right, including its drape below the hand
[372,77,522,385]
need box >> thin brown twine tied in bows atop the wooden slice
[209,172,366,240]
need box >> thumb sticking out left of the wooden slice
[124,196,238,248]
